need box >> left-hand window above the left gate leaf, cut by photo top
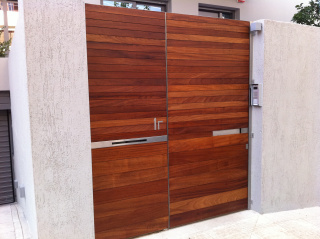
[101,0,168,12]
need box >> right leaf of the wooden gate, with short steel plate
[167,14,249,227]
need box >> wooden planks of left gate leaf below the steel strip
[92,142,168,238]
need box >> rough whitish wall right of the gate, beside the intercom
[252,21,320,212]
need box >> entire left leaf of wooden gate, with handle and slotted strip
[86,5,169,239]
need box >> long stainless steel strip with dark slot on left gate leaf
[91,135,168,149]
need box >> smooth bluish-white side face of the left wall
[9,1,38,238]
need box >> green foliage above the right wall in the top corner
[292,0,320,27]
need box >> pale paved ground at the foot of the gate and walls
[0,204,320,239]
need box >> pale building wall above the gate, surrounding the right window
[171,0,309,22]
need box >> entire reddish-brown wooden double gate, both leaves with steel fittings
[86,5,249,238]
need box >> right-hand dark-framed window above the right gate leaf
[199,3,240,20]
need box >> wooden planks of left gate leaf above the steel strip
[86,5,167,142]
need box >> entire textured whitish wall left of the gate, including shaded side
[10,0,94,239]
